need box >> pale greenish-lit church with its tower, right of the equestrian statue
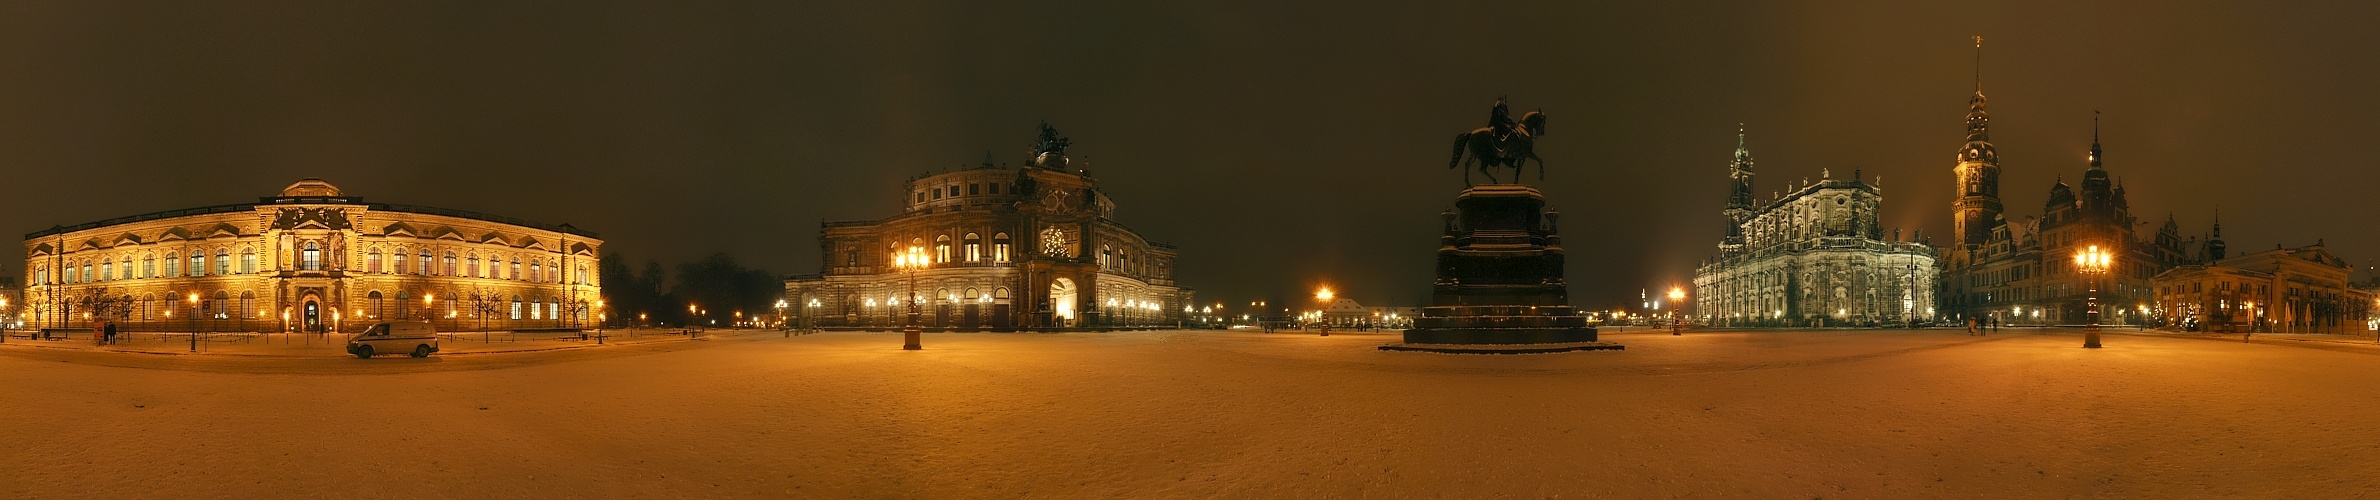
[1692,133,1935,326]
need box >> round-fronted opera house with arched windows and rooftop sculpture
[785,124,1192,331]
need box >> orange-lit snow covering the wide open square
[0,331,2380,498]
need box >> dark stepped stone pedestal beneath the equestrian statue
[1383,183,1621,352]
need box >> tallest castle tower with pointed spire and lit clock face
[1949,36,2002,262]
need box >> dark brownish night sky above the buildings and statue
[0,0,2380,310]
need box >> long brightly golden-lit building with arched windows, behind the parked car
[14,179,602,331]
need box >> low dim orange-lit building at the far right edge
[2149,240,2373,333]
